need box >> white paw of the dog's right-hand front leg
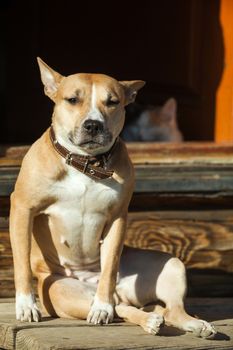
[87,297,114,324]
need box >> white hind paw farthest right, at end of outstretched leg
[183,320,217,338]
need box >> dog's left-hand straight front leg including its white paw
[10,194,41,322]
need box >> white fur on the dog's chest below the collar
[44,167,122,267]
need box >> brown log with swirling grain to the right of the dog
[126,211,233,272]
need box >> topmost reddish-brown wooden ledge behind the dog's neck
[0,142,233,167]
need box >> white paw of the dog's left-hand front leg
[15,293,41,322]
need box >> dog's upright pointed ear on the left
[37,57,63,102]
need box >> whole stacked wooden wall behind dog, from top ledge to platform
[0,143,233,296]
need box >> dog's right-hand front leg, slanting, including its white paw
[87,214,127,324]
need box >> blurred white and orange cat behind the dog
[121,98,183,142]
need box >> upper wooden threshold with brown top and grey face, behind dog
[0,143,233,196]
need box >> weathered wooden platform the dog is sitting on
[0,298,233,350]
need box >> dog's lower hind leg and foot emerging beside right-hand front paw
[115,304,164,335]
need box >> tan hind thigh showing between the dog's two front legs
[38,274,96,319]
